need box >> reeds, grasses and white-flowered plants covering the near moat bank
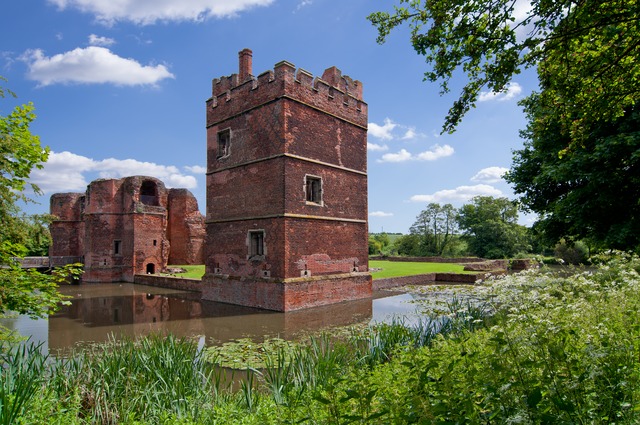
[5,253,640,424]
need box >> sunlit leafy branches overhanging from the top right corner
[368,0,640,139]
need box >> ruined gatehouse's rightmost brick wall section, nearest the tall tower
[167,189,205,264]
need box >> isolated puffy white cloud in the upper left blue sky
[21,46,174,86]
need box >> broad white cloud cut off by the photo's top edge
[48,0,274,25]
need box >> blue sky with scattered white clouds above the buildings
[0,0,537,233]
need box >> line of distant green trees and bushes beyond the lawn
[369,196,589,263]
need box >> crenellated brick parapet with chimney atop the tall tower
[207,49,367,126]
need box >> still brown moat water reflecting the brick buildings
[0,283,430,354]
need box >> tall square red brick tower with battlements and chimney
[203,49,371,311]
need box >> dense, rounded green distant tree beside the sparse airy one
[458,196,530,258]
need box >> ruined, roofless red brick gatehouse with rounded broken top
[50,176,204,282]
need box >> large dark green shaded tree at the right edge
[505,95,640,250]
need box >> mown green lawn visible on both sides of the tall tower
[162,260,468,279]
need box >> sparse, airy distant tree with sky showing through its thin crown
[409,202,457,256]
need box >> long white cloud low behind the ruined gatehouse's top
[30,152,198,193]
